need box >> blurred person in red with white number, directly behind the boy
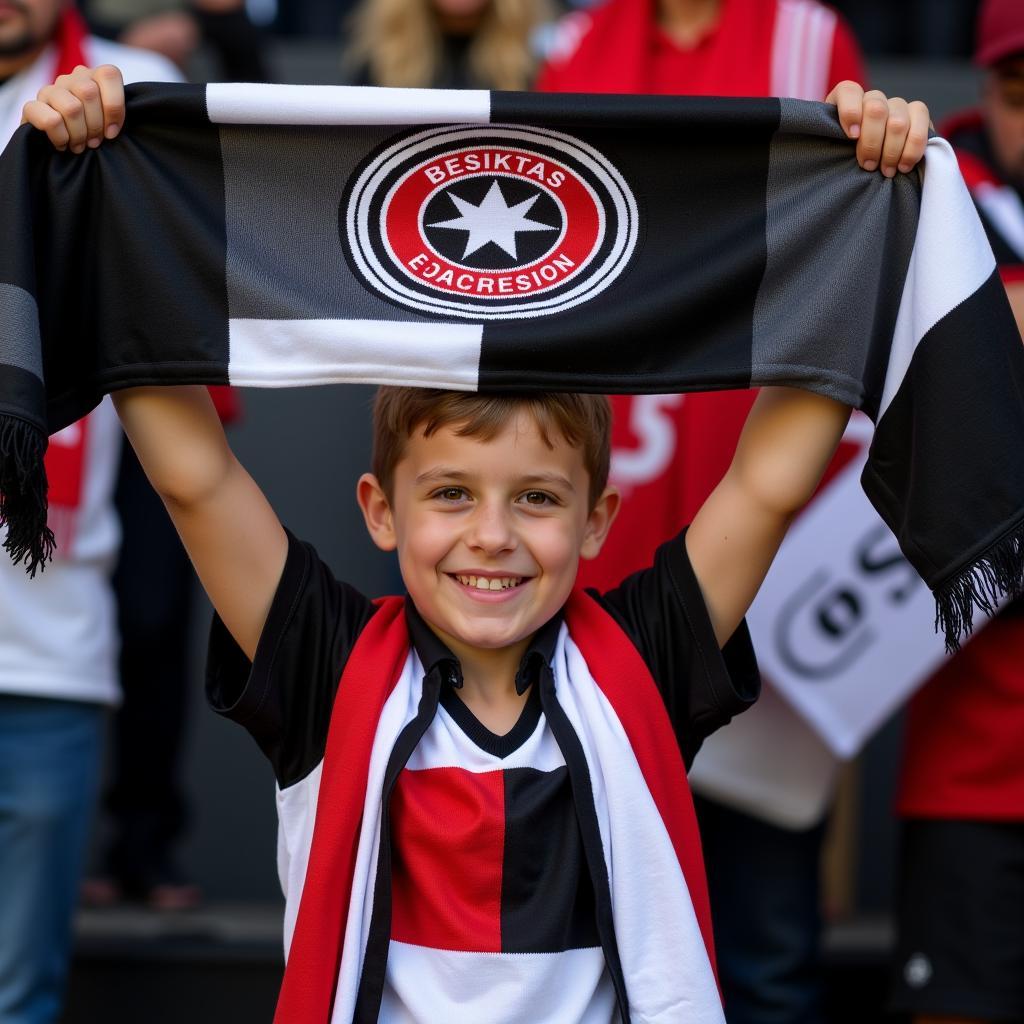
[537,0,865,586]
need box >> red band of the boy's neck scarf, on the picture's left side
[273,597,409,1024]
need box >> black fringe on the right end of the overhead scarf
[935,522,1024,654]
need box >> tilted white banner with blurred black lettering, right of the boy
[748,414,966,758]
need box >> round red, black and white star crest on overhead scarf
[341,125,637,319]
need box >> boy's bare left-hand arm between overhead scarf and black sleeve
[114,386,288,659]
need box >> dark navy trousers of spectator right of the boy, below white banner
[694,797,824,1024]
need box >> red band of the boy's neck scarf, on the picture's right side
[565,590,718,977]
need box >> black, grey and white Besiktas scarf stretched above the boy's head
[0,85,1024,647]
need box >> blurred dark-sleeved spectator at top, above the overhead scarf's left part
[83,0,269,82]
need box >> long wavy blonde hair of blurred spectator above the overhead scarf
[345,0,552,89]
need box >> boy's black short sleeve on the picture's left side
[206,534,376,788]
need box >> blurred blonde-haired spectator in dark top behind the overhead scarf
[345,0,551,89]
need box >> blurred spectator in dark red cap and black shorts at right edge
[894,0,1024,1024]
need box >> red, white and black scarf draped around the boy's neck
[274,591,725,1024]
